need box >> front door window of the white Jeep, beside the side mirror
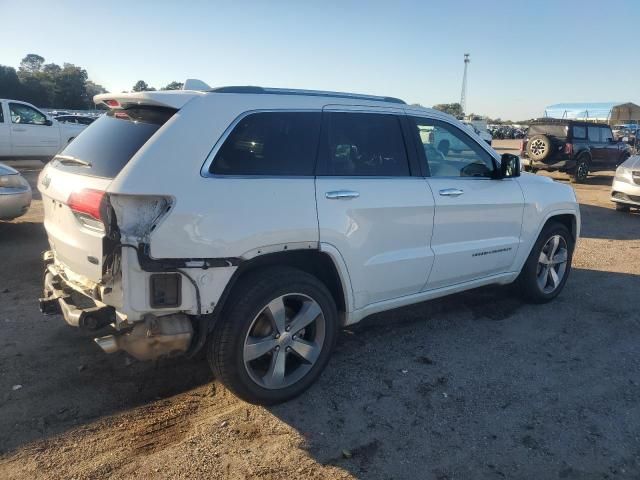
[412,118,494,177]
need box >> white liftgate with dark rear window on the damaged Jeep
[38,107,175,282]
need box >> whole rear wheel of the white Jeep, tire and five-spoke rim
[208,267,338,405]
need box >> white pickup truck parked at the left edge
[0,98,87,161]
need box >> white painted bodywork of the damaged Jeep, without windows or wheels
[40,88,580,324]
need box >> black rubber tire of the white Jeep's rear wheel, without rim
[207,267,338,405]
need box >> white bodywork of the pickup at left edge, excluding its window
[0,99,87,158]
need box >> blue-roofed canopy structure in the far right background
[544,102,640,124]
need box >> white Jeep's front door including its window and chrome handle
[411,117,524,290]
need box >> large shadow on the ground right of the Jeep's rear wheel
[270,269,640,478]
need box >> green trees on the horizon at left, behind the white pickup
[0,53,183,110]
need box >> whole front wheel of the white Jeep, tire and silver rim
[516,221,575,303]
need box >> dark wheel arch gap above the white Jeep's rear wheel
[213,249,351,324]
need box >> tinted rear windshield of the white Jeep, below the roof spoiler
[53,107,176,178]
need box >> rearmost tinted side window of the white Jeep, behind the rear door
[209,112,321,176]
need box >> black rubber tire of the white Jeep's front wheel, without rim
[515,221,575,303]
